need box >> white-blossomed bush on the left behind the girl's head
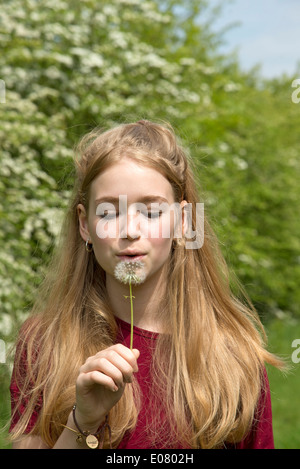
[0,0,210,344]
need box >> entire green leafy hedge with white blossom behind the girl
[0,0,300,348]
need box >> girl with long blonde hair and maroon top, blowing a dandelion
[10,121,280,449]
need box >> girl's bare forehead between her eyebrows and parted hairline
[90,158,174,203]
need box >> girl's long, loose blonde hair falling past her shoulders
[9,121,280,448]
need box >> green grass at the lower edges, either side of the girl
[0,318,300,449]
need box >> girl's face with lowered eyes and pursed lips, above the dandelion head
[78,157,183,284]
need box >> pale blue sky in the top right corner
[209,0,300,78]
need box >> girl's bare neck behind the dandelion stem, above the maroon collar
[106,266,165,332]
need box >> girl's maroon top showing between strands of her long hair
[10,319,274,449]
